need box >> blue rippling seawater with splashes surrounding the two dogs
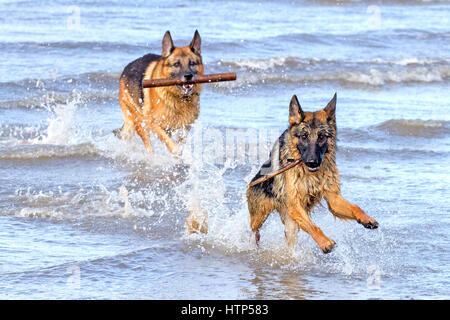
[0,0,450,299]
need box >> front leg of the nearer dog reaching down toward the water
[288,205,336,253]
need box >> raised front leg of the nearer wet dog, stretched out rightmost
[325,193,378,229]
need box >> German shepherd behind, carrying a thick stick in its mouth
[115,30,204,153]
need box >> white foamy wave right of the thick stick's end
[216,57,450,89]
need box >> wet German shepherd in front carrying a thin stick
[247,94,378,253]
